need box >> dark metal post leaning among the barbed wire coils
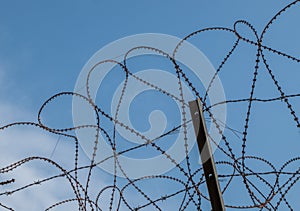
[189,99,225,211]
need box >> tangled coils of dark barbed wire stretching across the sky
[0,0,300,210]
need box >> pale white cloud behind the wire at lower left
[0,102,111,211]
